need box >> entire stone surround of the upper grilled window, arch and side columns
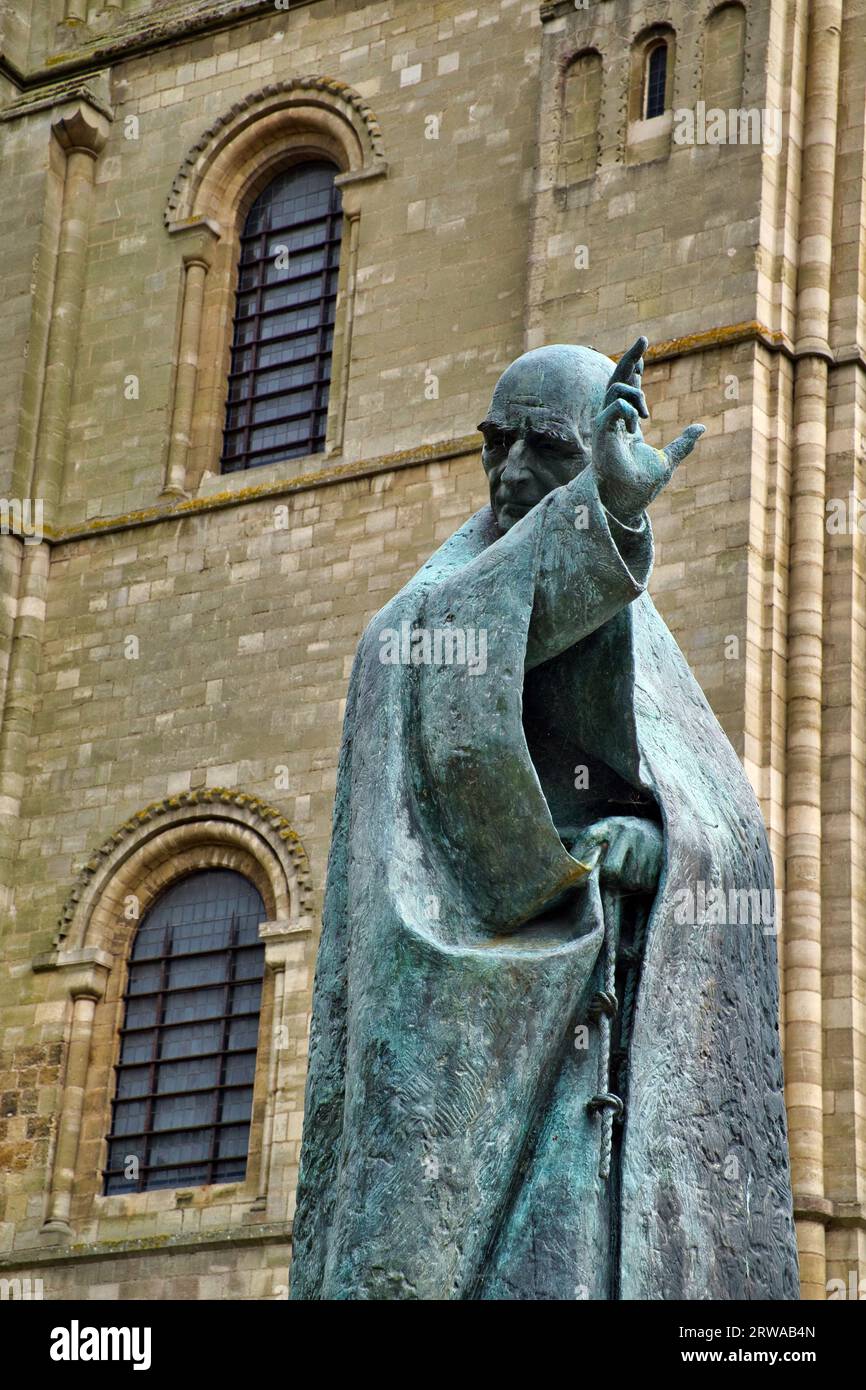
[163,76,388,496]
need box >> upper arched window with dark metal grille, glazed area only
[222,160,342,473]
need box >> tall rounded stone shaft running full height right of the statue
[784,0,842,1300]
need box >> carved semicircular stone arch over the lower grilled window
[54,787,313,949]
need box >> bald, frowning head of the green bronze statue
[478,345,613,531]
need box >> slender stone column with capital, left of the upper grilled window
[163,218,220,496]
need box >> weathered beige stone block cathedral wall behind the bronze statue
[0,0,866,1298]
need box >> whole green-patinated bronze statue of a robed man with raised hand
[292,338,798,1300]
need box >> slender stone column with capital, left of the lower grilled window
[36,947,113,1241]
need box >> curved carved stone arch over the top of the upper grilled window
[163,76,386,227]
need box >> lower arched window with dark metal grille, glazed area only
[104,869,265,1193]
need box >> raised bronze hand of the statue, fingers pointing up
[592,338,703,525]
